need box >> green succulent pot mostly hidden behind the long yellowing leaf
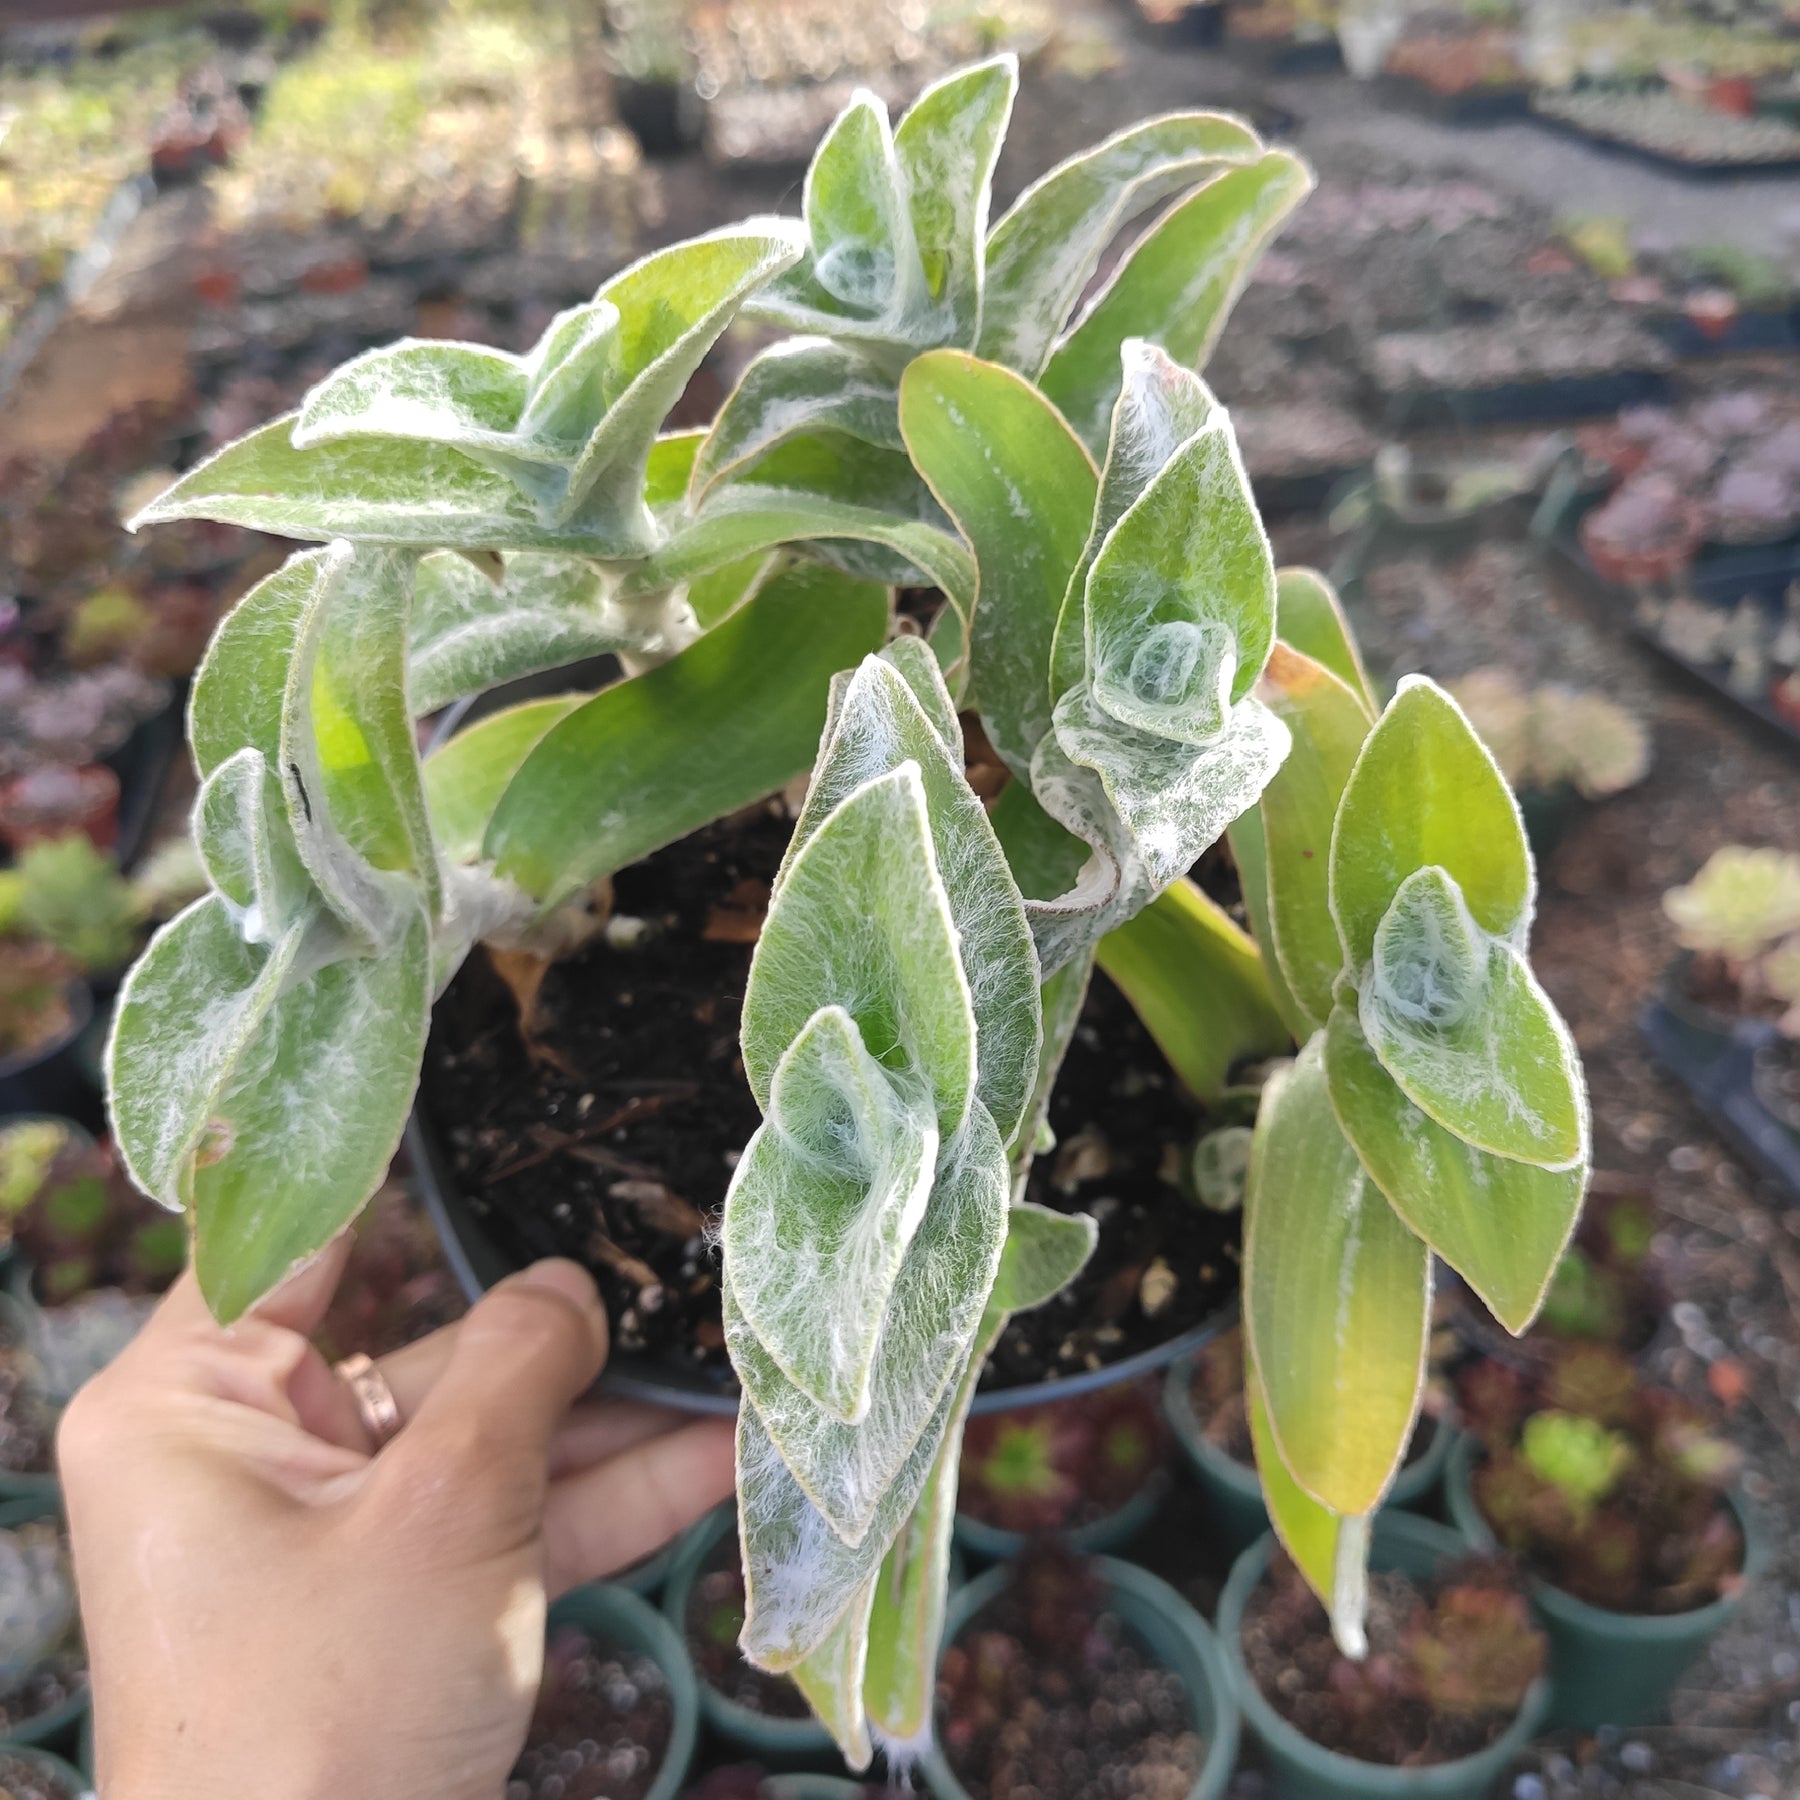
[1163,1327,1458,1557]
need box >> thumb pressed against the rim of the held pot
[382,1260,607,1481]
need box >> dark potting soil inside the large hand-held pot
[423,801,1238,1391]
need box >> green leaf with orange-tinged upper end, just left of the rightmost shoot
[1256,643,1370,1031]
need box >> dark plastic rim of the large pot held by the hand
[407,1103,1238,1415]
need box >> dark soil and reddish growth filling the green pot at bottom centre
[938,1553,1206,1800]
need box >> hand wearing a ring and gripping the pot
[58,1240,731,1800]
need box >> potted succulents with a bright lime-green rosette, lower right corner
[1447,1345,1764,1730]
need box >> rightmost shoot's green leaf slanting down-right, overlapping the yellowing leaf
[1325,1004,1588,1334]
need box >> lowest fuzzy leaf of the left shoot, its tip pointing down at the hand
[185,911,432,1325]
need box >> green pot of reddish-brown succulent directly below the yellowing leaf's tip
[1219,1514,1550,1800]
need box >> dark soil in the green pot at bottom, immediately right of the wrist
[506,1627,675,1800]
